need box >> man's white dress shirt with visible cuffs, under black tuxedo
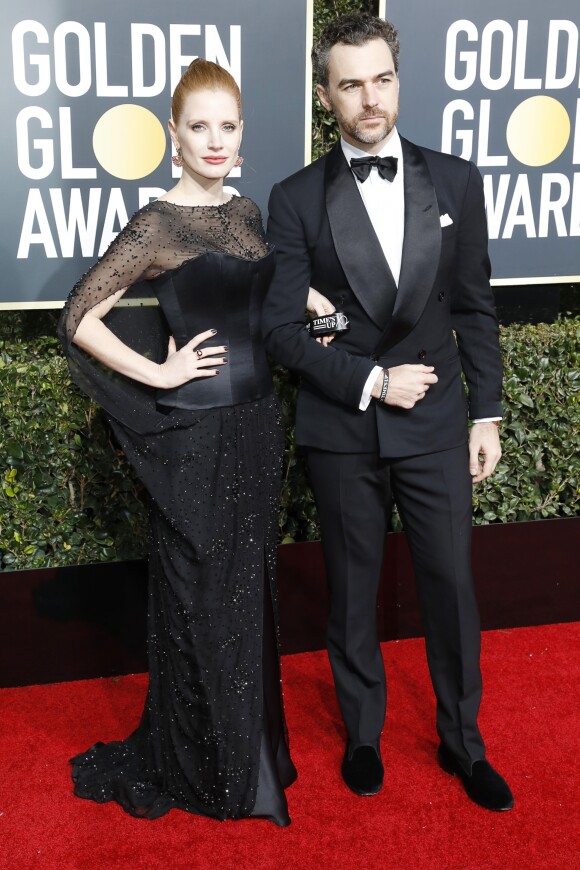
[340,128,501,423]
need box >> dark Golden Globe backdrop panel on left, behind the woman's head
[0,0,312,308]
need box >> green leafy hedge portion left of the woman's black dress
[0,337,144,569]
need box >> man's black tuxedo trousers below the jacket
[308,445,485,772]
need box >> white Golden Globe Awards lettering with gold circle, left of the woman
[11,19,241,260]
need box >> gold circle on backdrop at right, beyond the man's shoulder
[507,95,570,166]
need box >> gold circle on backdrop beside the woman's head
[93,103,167,181]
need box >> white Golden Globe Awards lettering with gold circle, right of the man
[441,19,580,239]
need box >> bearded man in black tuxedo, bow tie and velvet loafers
[264,14,513,810]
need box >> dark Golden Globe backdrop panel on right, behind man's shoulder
[386,0,580,284]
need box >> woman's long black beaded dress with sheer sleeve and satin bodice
[59,197,296,825]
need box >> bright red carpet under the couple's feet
[0,624,580,870]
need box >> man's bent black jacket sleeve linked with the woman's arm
[262,185,375,409]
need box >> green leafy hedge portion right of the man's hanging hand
[475,317,580,523]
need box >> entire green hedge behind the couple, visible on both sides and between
[0,318,580,570]
